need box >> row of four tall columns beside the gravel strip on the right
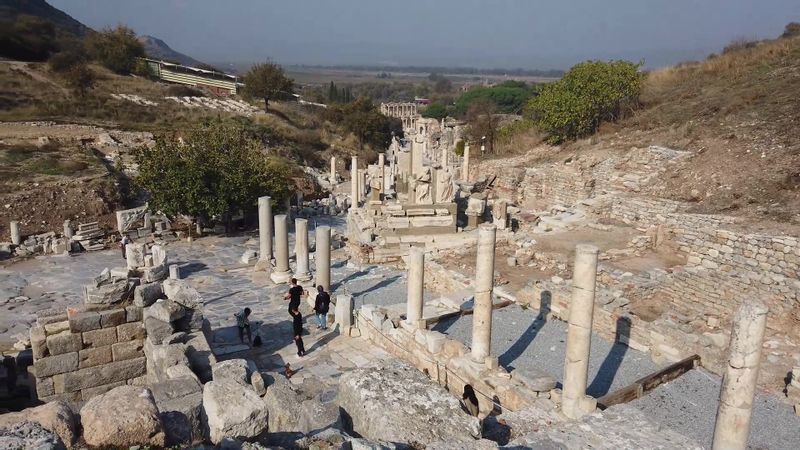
[406,229,769,450]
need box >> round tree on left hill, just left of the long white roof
[86,25,145,74]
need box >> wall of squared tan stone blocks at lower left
[31,305,146,402]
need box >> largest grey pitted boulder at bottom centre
[336,362,480,445]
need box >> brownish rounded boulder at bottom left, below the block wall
[81,386,165,447]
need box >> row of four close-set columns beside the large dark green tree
[258,196,331,290]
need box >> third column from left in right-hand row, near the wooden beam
[561,244,599,419]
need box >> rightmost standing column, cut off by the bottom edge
[712,302,768,450]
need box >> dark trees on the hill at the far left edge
[0,14,58,61]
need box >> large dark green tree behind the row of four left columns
[135,121,291,227]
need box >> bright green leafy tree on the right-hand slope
[526,61,644,143]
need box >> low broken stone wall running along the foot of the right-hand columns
[355,305,560,416]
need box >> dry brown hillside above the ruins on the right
[517,37,800,224]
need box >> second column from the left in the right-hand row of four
[472,223,497,363]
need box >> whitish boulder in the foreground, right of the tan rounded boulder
[203,380,269,444]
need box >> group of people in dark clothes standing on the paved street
[235,278,331,357]
